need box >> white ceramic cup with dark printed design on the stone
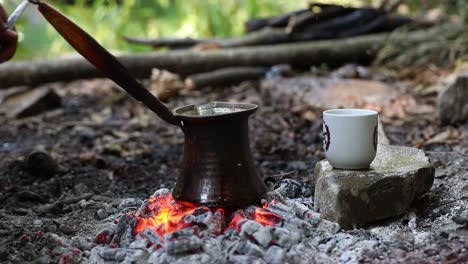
[323,109,379,170]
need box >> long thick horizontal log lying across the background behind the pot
[0,31,431,88]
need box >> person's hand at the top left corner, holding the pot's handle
[0,4,18,63]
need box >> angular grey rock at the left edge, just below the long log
[0,87,62,118]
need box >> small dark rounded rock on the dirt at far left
[26,151,58,178]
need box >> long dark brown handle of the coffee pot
[36,1,180,126]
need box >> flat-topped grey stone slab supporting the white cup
[313,144,434,229]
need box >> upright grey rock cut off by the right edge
[437,74,468,124]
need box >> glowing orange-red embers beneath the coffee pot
[133,194,282,237]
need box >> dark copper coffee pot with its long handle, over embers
[29,0,266,207]
